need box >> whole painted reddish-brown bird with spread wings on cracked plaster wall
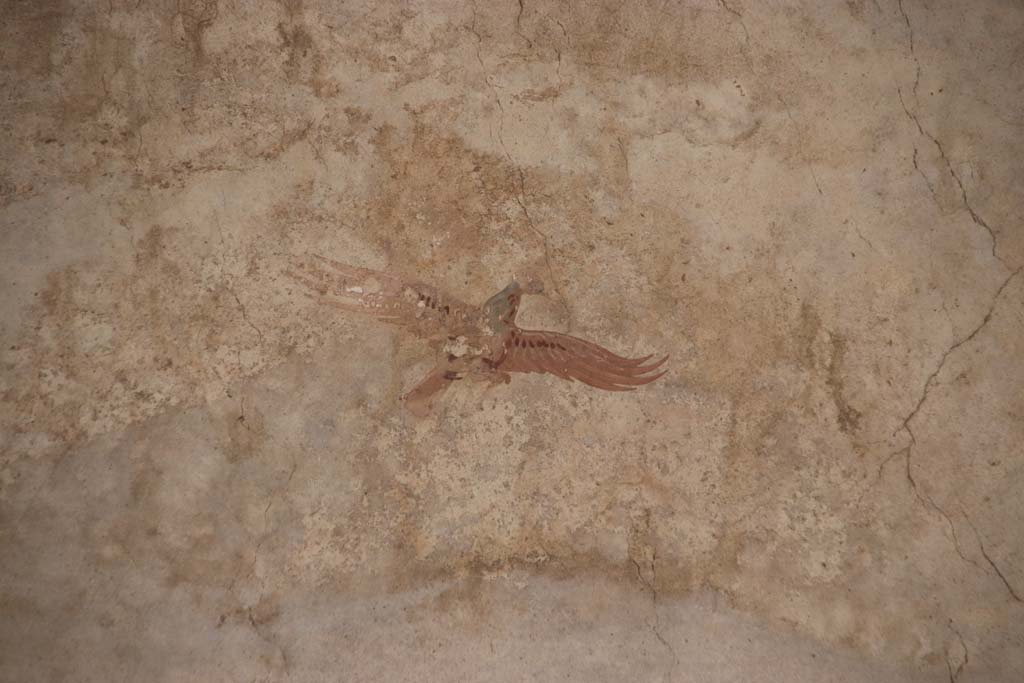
[287,256,669,416]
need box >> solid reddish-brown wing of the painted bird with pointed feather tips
[495,329,669,391]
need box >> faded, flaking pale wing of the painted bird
[286,255,476,334]
